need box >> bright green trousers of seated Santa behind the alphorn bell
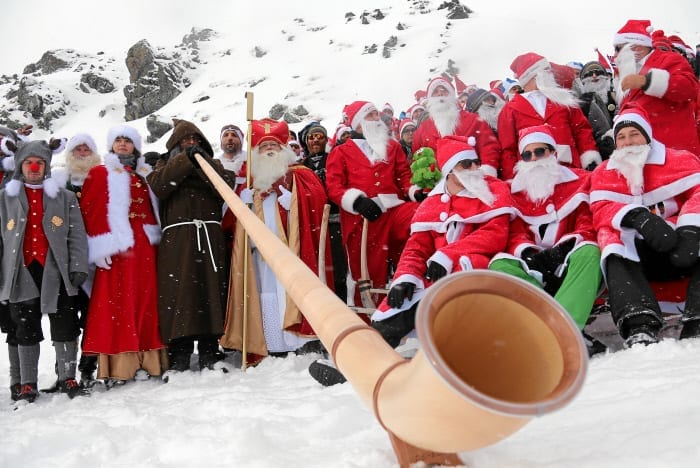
[489,245,602,329]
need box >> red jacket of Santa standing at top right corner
[620,49,700,155]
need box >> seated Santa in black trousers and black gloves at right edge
[590,106,700,346]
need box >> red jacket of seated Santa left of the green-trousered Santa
[372,176,513,321]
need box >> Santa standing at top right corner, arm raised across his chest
[613,20,700,154]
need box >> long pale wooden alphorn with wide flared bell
[196,156,588,453]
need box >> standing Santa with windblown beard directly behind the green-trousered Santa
[498,52,602,180]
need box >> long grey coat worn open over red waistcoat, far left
[0,179,88,314]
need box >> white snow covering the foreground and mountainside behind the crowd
[0,0,700,468]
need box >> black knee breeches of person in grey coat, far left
[8,261,80,346]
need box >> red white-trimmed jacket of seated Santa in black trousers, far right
[590,140,700,272]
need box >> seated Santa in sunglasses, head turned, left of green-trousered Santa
[309,136,514,386]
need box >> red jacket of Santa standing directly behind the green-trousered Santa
[498,91,600,180]
